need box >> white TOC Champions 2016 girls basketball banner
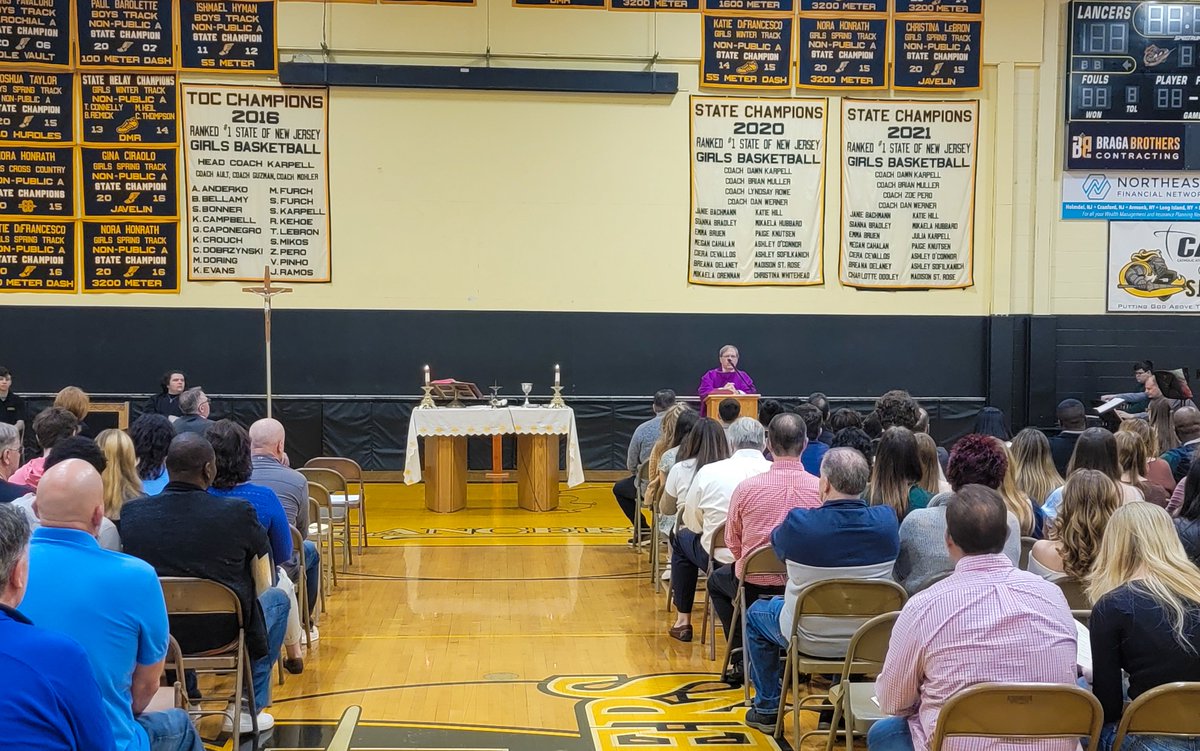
[184,85,330,282]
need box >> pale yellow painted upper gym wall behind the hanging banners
[11,0,1105,316]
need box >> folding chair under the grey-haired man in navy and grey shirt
[775,579,908,749]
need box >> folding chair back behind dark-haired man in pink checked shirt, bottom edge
[929,683,1104,751]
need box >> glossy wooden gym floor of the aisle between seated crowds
[210,483,823,751]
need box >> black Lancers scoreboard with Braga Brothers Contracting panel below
[1067,0,1200,170]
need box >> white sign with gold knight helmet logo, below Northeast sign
[1108,222,1200,313]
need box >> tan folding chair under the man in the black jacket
[158,577,258,751]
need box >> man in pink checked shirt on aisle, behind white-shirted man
[708,413,821,683]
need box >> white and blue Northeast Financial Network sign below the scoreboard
[1062,172,1200,215]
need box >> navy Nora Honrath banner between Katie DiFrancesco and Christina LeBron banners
[796,16,888,89]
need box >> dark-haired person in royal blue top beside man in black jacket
[205,420,304,674]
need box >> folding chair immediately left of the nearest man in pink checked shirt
[816,613,900,751]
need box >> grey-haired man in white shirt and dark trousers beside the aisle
[667,417,770,642]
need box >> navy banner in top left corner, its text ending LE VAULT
[0,0,71,68]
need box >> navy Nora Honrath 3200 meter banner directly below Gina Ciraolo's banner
[83,220,179,293]
